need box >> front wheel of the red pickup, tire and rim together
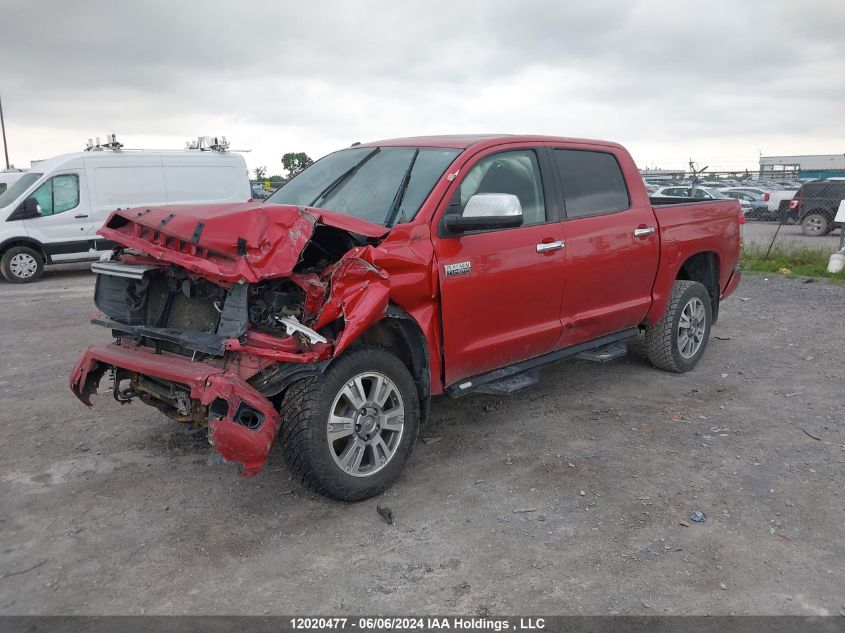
[279,346,420,501]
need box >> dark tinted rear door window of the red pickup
[554,149,631,218]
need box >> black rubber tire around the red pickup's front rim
[279,345,420,501]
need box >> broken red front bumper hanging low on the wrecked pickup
[70,344,280,477]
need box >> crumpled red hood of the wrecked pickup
[98,203,390,283]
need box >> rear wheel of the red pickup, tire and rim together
[645,280,713,372]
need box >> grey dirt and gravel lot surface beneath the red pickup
[0,270,845,614]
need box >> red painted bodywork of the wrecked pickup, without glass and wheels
[70,135,740,475]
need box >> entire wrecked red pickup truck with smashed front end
[70,135,741,500]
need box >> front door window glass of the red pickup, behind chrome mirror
[459,149,546,226]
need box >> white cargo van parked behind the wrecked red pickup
[0,147,252,283]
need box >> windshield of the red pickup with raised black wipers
[267,147,461,226]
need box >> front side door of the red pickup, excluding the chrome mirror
[434,146,564,384]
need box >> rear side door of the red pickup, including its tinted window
[550,144,660,347]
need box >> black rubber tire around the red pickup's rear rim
[645,280,713,372]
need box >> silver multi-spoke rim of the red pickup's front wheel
[326,371,405,477]
